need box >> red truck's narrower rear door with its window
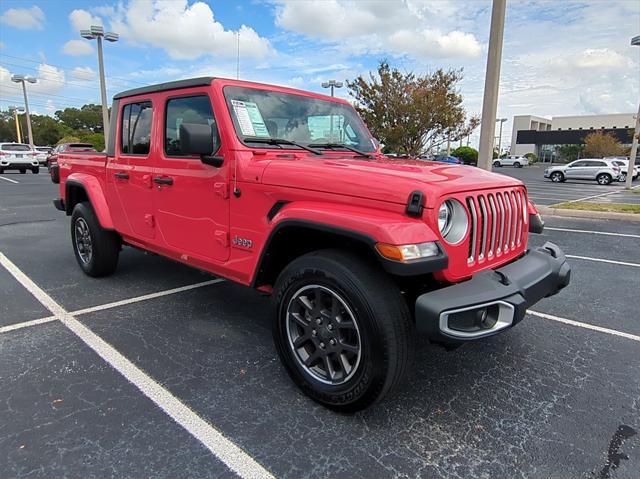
[107,101,155,240]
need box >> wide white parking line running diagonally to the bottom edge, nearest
[0,253,273,478]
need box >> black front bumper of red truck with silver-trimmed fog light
[415,243,571,343]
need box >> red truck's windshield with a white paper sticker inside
[224,86,376,152]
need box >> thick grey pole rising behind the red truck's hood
[478,0,507,171]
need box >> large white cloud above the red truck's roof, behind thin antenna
[109,0,271,60]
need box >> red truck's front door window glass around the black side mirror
[164,95,220,157]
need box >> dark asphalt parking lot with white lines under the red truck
[0,168,640,479]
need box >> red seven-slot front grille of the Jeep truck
[465,188,528,265]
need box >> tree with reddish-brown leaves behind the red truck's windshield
[347,61,479,156]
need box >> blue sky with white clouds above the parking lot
[0,0,640,146]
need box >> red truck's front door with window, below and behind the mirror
[153,91,229,262]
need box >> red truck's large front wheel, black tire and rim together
[273,250,414,412]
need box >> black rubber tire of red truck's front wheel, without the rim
[273,249,415,413]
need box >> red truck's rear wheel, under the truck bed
[71,202,120,277]
